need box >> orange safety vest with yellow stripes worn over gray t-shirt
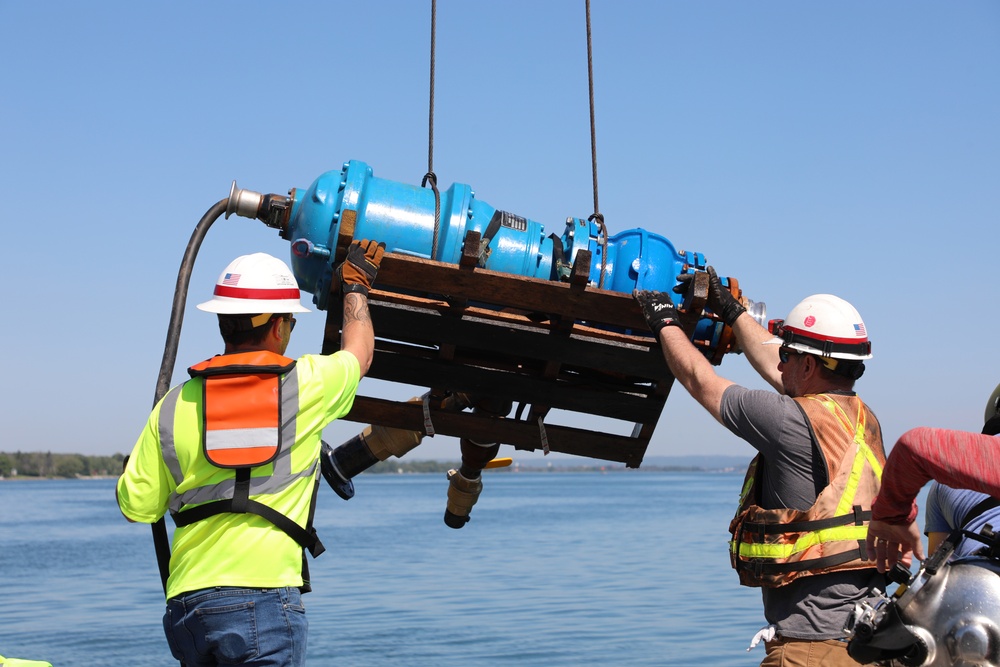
[729,394,885,587]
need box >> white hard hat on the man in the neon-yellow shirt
[198,252,309,315]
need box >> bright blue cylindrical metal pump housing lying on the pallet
[283,160,722,341]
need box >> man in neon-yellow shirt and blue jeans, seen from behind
[117,241,385,666]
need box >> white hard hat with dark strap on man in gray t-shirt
[764,294,872,361]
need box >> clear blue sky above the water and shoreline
[0,0,1000,459]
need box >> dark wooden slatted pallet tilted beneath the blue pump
[323,232,674,468]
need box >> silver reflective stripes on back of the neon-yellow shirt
[160,368,319,512]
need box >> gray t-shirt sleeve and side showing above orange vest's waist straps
[720,385,826,510]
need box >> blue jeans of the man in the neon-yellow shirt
[163,588,309,667]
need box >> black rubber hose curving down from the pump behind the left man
[151,197,229,595]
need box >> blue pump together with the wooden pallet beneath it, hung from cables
[226,161,765,469]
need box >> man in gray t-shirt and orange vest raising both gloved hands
[635,267,885,667]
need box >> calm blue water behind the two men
[0,471,764,667]
